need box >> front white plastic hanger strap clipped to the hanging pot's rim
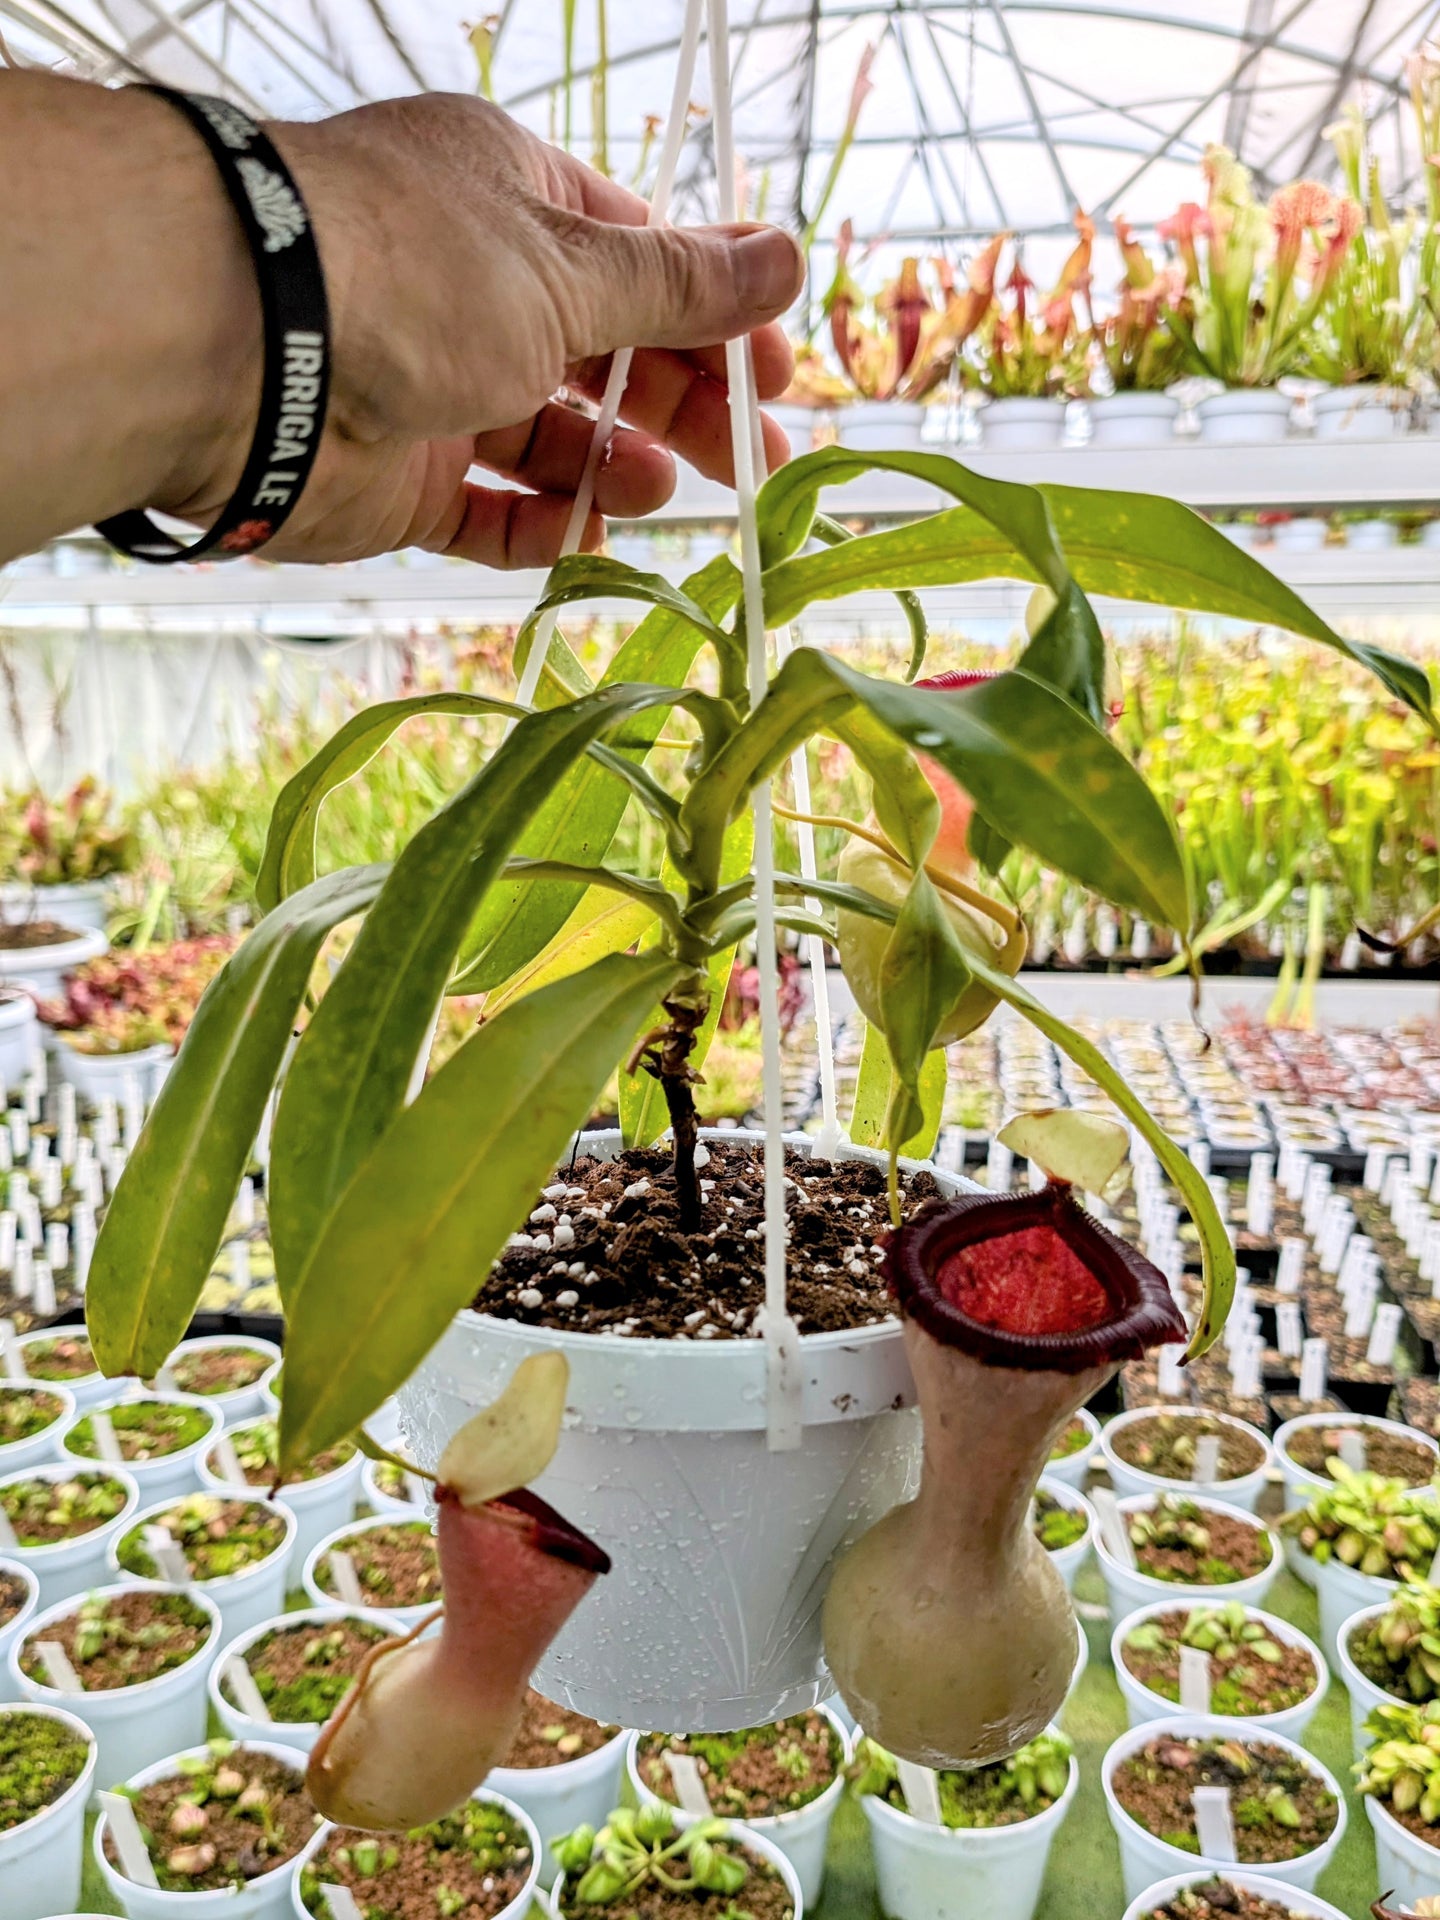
[707,0,804,1453]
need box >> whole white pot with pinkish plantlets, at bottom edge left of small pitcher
[94,1740,319,1920]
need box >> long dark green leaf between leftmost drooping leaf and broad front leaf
[271,685,698,1309]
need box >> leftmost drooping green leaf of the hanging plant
[84,866,388,1379]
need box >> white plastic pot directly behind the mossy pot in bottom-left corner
[6,1580,221,1788]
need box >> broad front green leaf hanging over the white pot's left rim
[280,954,684,1469]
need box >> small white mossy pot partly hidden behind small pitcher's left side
[209,1607,399,1753]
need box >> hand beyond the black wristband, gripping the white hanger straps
[166,94,803,566]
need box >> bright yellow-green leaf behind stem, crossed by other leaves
[455,555,739,993]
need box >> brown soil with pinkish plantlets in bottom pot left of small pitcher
[106,1747,319,1893]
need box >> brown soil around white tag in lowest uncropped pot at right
[1112,1734,1338,1866]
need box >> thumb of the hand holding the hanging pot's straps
[561,219,804,361]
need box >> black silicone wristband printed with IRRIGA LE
[96,86,330,566]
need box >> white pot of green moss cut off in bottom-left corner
[0,1705,96,1920]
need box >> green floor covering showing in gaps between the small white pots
[73,1565,1380,1920]
